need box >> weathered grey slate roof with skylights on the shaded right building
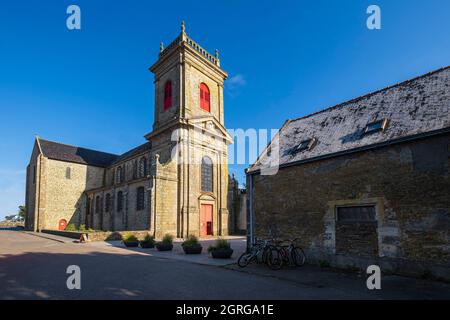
[249,66,450,172]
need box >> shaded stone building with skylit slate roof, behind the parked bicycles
[247,67,450,279]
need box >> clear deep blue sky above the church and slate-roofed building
[0,0,450,218]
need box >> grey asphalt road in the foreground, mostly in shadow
[0,231,450,300]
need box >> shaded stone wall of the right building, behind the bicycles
[252,134,450,278]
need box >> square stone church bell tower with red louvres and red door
[146,22,232,237]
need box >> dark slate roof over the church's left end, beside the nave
[39,138,119,167]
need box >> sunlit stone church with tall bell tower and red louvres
[26,23,232,237]
